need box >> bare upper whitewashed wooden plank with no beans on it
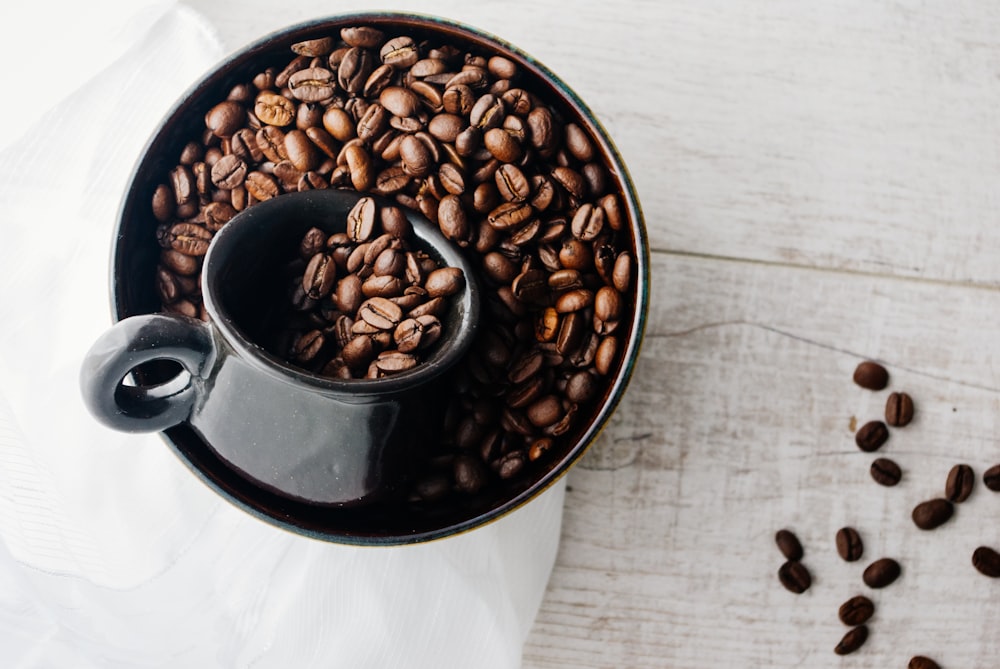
[185,0,1000,286]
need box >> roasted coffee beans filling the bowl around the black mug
[150,20,635,504]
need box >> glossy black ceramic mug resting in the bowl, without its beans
[81,190,479,505]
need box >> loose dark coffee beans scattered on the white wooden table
[775,360,1000,669]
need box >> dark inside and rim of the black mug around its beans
[203,189,479,400]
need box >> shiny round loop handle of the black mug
[80,314,216,432]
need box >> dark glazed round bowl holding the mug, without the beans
[110,12,649,545]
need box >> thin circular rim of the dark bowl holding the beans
[109,11,650,546]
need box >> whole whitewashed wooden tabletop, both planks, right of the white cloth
[186,0,1000,669]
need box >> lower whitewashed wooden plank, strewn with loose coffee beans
[525,249,1000,669]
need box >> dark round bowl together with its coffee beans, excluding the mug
[105,13,648,543]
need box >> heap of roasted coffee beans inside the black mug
[280,197,465,379]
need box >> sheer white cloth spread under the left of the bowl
[0,0,564,669]
